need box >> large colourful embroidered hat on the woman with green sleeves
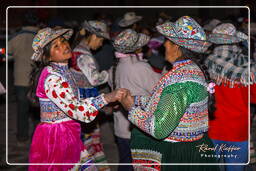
[156,16,211,53]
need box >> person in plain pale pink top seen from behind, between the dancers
[109,29,161,171]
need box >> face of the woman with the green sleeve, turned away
[164,40,181,63]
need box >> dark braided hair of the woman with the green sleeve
[179,46,216,120]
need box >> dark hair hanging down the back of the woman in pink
[27,43,51,106]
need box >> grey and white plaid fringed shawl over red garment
[205,45,256,88]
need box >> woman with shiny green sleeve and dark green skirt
[121,16,218,171]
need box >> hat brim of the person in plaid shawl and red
[208,33,246,44]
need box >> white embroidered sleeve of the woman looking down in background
[77,54,108,86]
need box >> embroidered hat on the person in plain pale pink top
[113,29,150,53]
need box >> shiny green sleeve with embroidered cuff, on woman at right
[128,82,207,139]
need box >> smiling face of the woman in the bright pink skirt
[50,37,72,63]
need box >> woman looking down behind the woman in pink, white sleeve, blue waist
[71,21,109,171]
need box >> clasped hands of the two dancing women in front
[104,88,134,110]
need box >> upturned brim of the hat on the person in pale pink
[114,33,150,53]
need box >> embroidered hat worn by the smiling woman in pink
[31,27,73,61]
